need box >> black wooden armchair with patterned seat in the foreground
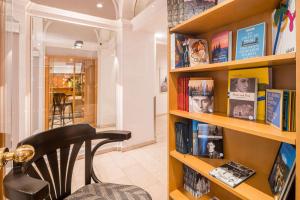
[3,124,151,200]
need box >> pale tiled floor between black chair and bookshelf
[72,116,167,200]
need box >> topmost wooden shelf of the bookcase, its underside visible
[171,0,278,34]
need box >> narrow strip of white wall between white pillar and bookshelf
[155,44,168,115]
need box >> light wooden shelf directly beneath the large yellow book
[170,110,296,145]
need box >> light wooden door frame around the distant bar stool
[44,55,99,130]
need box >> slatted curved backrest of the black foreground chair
[14,124,96,199]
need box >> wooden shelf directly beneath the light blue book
[171,53,296,73]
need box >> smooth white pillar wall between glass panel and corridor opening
[117,23,155,147]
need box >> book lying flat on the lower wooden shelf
[209,161,255,188]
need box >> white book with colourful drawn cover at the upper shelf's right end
[272,0,296,55]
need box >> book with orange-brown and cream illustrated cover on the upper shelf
[189,38,209,67]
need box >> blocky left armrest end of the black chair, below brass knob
[3,170,49,200]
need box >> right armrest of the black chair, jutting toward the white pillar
[92,130,131,141]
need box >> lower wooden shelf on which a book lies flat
[170,151,274,200]
